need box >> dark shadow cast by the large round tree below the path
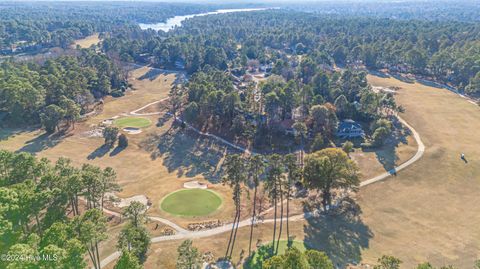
[304,199,373,268]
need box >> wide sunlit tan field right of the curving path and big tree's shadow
[359,76,480,268]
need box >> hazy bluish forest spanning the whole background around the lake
[0,1,480,94]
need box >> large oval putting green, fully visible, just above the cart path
[160,189,222,217]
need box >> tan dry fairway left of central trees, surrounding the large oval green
[0,67,238,226]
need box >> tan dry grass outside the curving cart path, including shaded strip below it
[146,76,480,268]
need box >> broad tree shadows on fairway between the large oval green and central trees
[140,126,236,182]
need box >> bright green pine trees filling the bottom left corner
[0,150,119,268]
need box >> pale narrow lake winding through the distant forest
[138,8,267,32]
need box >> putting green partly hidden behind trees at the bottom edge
[244,240,309,269]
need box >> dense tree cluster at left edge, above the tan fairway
[0,50,127,132]
